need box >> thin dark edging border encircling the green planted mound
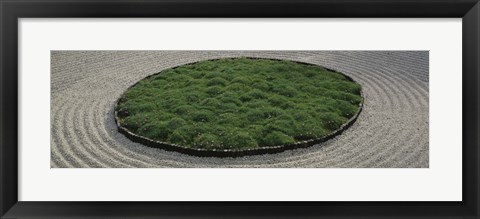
[114,57,365,157]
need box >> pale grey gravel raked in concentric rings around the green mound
[50,51,429,168]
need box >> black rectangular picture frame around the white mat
[0,0,480,218]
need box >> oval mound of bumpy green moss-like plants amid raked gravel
[115,58,362,150]
